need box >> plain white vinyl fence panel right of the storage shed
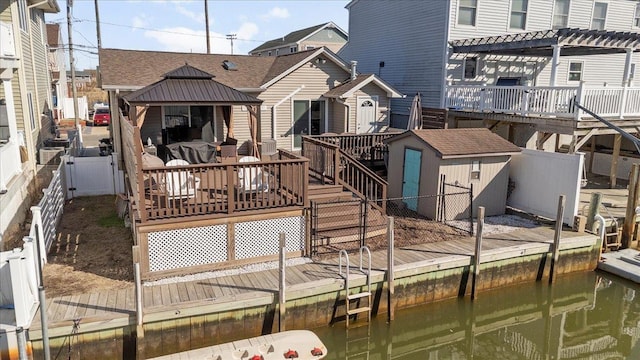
[507,149,584,225]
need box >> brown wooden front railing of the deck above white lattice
[142,158,308,220]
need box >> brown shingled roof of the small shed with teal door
[386,128,522,159]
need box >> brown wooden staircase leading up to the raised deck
[309,184,387,253]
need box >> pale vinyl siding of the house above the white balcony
[447,0,640,86]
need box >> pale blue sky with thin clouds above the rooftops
[45,0,349,70]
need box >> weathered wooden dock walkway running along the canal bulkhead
[30,227,596,340]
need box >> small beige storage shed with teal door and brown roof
[386,128,521,219]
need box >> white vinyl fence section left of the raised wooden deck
[63,153,124,199]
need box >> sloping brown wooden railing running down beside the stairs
[302,136,388,212]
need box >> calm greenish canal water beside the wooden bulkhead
[314,273,640,360]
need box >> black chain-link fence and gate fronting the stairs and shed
[311,177,473,256]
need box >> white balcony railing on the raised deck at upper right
[446,84,640,119]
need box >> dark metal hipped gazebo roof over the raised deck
[124,64,262,104]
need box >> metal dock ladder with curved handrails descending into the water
[338,246,372,328]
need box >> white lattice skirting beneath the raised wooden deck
[148,216,305,272]
